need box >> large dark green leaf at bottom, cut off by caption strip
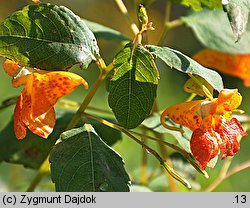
[50,125,130,192]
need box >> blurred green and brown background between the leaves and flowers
[0,0,250,191]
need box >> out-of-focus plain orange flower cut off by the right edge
[193,49,250,87]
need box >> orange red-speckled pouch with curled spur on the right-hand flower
[161,100,204,131]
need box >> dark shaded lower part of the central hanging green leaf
[108,68,157,129]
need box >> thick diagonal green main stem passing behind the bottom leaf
[27,57,113,192]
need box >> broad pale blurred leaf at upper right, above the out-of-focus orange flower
[182,10,250,54]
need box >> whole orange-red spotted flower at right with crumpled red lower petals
[161,89,247,169]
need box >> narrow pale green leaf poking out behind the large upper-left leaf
[83,20,130,41]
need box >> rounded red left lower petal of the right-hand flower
[190,128,219,169]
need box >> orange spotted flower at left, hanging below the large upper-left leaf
[4,60,88,139]
